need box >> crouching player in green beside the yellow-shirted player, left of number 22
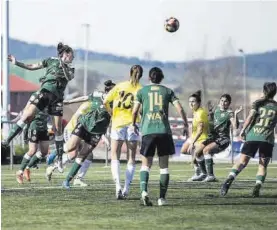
[199,94,242,182]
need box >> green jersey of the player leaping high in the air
[41,57,75,98]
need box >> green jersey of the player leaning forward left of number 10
[78,91,111,135]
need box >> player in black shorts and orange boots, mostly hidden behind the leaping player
[16,93,49,184]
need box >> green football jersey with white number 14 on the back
[135,84,178,136]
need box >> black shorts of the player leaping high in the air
[29,89,63,117]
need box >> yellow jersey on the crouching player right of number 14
[192,107,209,143]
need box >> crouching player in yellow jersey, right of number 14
[181,90,209,181]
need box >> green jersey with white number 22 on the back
[246,99,277,145]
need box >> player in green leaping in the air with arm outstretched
[2,43,74,172]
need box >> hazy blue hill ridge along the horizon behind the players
[2,39,277,90]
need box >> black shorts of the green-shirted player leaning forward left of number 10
[72,123,102,148]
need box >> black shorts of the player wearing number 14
[140,134,175,157]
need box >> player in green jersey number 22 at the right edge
[220,82,277,197]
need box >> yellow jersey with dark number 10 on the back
[104,81,142,129]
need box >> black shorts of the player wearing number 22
[241,141,274,158]
